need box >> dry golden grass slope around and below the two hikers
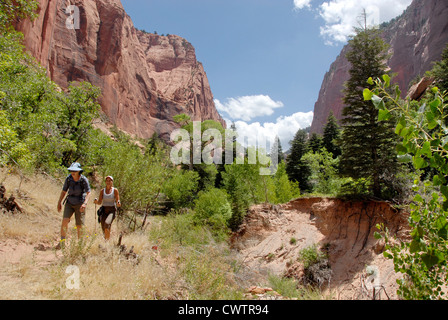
[0,169,242,300]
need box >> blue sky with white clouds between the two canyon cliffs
[121,0,411,150]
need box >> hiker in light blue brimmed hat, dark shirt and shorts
[58,162,90,248]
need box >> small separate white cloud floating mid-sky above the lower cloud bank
[215,95,283,121]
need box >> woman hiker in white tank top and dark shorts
[93,176,121,240]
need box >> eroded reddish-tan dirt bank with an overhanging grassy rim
[232,198,406,299]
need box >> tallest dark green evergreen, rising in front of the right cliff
[340,27,398,197]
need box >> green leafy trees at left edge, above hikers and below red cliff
[0,31,99,172]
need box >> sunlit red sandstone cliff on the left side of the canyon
[17,0,225,140]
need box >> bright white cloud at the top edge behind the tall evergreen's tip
[294,0,412,45]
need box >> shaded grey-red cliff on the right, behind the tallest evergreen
[311,0,448,133]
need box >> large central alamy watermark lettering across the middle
[170,121,278,175]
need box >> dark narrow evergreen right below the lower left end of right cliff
[286,129,311,192]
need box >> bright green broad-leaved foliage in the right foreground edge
[364,76,448,299]
